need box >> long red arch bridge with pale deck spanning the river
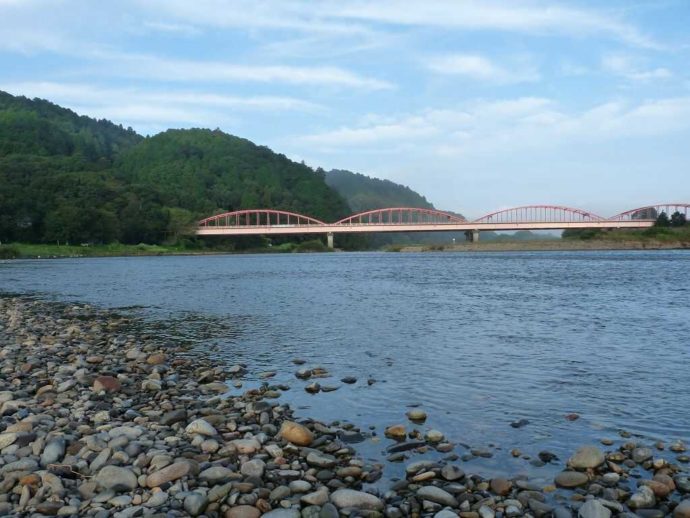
[196,203,690,248]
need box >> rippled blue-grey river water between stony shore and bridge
[0,251,690,484]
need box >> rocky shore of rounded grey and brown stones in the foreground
[0,297,690,518]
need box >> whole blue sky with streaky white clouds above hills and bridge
[0,0,690,217]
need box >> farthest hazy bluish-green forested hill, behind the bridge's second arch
[326,169,434,212]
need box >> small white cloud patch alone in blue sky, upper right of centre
[426,54,540,84]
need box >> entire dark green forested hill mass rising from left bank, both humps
[0,92,351,243]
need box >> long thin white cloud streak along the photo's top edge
[139,0,660,48]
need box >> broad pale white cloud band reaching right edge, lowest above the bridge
[299,97,690,156]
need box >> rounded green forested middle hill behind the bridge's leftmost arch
[116,129,350,221]
